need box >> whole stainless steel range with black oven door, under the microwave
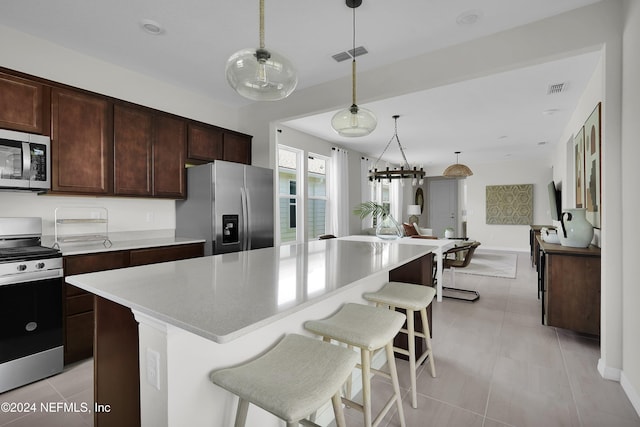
[0,218,64,393]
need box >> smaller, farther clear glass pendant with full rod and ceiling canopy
[331,0,378,137]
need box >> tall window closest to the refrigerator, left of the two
[278,146,301,243]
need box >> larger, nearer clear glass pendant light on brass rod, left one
[225,0,298,101]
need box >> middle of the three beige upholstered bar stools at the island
[304,304,406,427]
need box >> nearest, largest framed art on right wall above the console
[584,103,602,228]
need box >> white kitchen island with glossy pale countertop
[67,239,435,427]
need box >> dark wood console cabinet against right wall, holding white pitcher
[536,236,600,336]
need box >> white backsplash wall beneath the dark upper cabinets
[0,192,176,235]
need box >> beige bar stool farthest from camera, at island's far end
[363,282,436,408]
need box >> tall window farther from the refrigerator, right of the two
[307,154,327,240]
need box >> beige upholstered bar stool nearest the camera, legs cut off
[211,334,358,427]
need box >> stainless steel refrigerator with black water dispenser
[176,160,274,255]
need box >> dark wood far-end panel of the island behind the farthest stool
[389,254,434,360]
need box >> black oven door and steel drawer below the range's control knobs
[0,278,64,393]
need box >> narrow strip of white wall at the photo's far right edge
[620,0,640,413]
